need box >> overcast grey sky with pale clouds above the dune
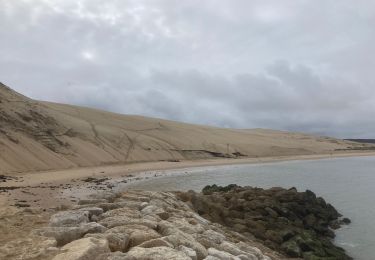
[0,0,375,138]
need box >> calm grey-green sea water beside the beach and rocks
[127,157,375,260]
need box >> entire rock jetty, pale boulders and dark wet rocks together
[34,185,351,260]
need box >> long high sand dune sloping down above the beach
[0,84,374,174]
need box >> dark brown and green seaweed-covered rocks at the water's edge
[179,185,351,260]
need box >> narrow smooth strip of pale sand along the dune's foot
[0,152,375,187]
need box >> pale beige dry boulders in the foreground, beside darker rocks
[34,191,281,260]
